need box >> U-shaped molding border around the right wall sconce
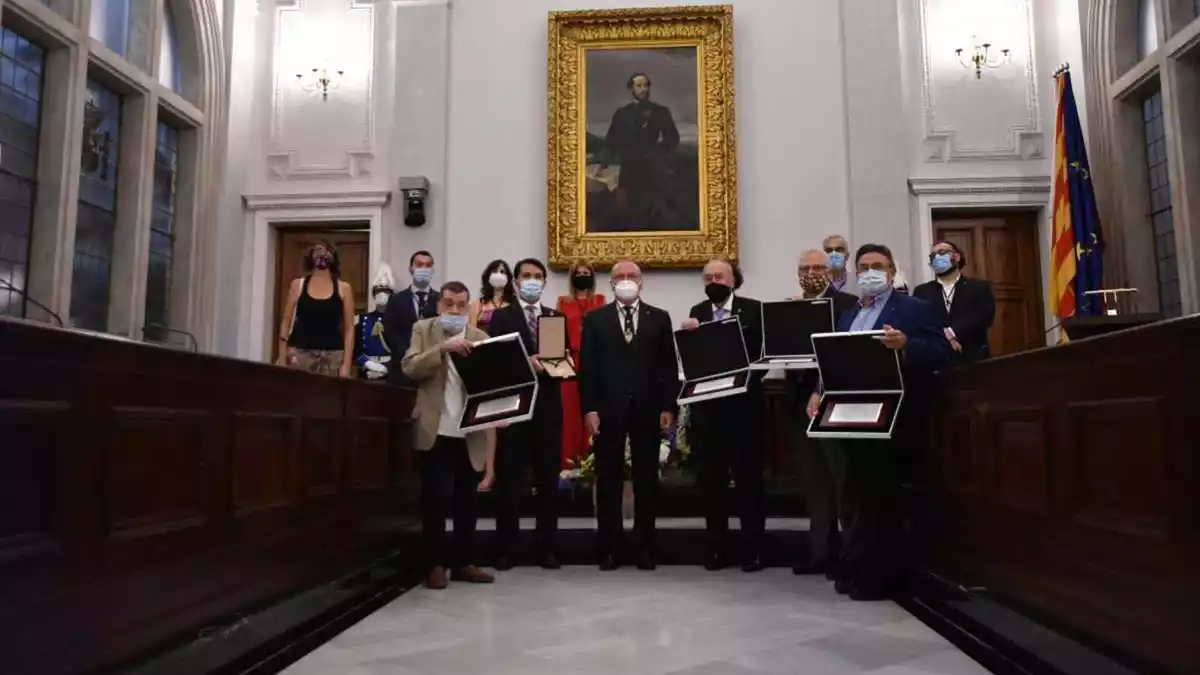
[918,0,1045,162]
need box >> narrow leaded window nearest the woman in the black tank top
[145,123,179,341]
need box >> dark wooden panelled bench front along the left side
[0,321,419,674]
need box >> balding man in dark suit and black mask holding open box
[683,261,767,572]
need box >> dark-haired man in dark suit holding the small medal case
[488,258,563,571]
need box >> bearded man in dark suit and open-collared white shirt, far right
[913,241,996,363]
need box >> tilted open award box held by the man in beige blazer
[450,333,538,431]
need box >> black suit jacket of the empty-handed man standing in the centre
[580,300,679,420]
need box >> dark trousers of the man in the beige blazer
[418,436,479,567]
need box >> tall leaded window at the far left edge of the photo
[0,28,46,316]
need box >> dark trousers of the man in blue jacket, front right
[828,440,904,593]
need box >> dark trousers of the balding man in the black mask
[692,393,767,550]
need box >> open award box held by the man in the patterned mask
[750,298,834,370]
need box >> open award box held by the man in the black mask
[674,316,750,405]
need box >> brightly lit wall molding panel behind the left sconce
[266,0,376,180]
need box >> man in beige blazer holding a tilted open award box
[401,281,496,589]
